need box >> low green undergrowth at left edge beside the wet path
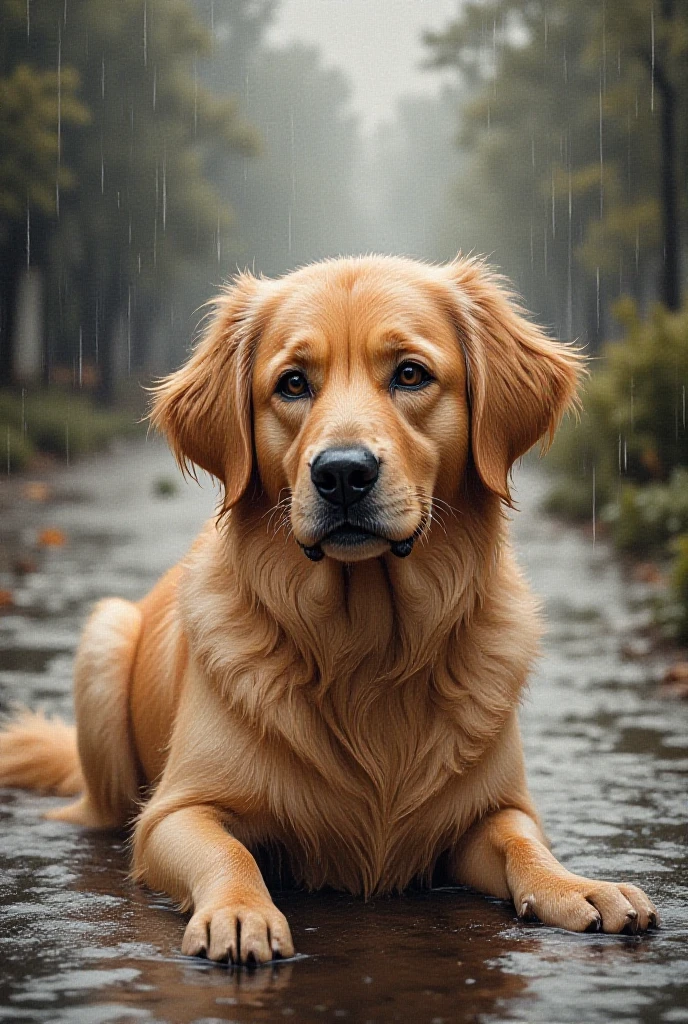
[0,388,140,460]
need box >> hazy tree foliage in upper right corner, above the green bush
[427,0,688,344]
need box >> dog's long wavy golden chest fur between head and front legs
[182,520,538,893]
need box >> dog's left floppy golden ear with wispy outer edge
[151,273,260,509]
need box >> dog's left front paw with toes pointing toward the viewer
[181,900,294,965]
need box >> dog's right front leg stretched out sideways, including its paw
[453,808,658,933]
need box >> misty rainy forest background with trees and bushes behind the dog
[0,0,688,618]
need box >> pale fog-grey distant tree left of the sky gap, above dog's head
[198,24,363,274]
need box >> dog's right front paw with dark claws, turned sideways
[514,873,659,935]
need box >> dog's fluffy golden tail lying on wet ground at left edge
[0,711,84,797]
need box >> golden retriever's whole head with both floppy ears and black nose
[152,257,581,562]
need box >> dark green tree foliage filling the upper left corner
[0,0,257,397]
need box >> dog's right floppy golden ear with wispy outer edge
[443,257,584,504]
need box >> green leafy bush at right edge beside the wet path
[546,300,688,640]
